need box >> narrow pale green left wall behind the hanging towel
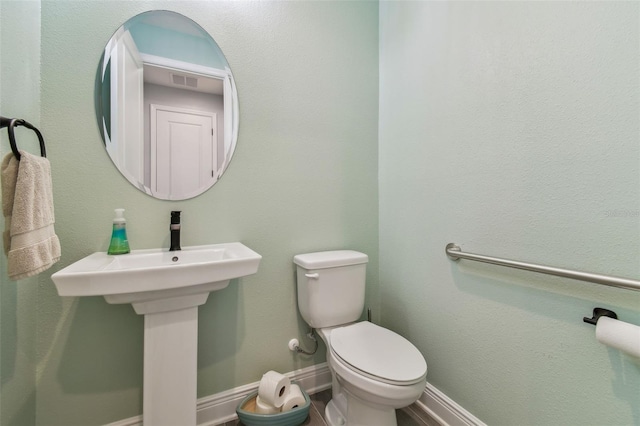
[0,1,40,426]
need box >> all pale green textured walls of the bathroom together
[0,1,640,425]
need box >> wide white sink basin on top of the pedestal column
[51,243,262,313]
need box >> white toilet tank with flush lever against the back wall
[293,250,369,328]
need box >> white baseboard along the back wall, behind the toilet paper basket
[105,363,331,426]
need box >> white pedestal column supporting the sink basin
[134,293,209,426]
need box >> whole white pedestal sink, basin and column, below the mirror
[51,243,262,426]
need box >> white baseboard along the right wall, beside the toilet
[416,383,486,426]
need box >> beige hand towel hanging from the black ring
[0,151,60,280]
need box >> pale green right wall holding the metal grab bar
[379,2,640,425]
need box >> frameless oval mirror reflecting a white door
[95,10,238,200]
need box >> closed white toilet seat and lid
[330,321,427,386]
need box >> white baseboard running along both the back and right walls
[105,363,486,426]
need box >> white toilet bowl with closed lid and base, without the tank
[318,321,427,426]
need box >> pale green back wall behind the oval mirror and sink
[34,1,378,425]
